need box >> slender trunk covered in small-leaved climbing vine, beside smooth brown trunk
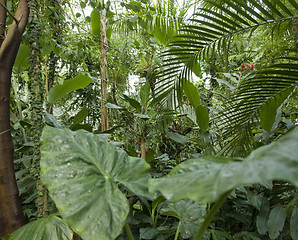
[28,0,47,217]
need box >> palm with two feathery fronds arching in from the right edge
[156,0,298,153]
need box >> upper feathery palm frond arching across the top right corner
[156,0,298,102]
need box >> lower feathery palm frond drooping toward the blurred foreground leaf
[215,57,298,155]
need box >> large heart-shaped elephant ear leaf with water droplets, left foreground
[40,127,150,240]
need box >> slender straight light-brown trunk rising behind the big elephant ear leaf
[100,9,109,132]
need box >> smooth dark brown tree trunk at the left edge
[0,0,29,238]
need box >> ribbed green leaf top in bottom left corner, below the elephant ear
[9,214,73,240]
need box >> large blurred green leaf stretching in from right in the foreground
[150,129,298,202]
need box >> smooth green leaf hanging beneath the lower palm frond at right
[260,87,294,132]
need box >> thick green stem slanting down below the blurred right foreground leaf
[195,190,233,240]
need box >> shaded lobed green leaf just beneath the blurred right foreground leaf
[160,200,206,239]
